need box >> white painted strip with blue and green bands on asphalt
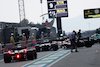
[22,49,71,67]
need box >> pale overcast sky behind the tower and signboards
[0,0,100,32]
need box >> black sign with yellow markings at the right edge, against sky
[84,8,100,19]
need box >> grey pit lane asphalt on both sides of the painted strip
[0,44,100,67]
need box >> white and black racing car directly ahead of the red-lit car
[36,40,58,52]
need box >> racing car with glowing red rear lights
[4,44,37,63]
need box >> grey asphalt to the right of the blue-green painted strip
[50,43,100,67]
